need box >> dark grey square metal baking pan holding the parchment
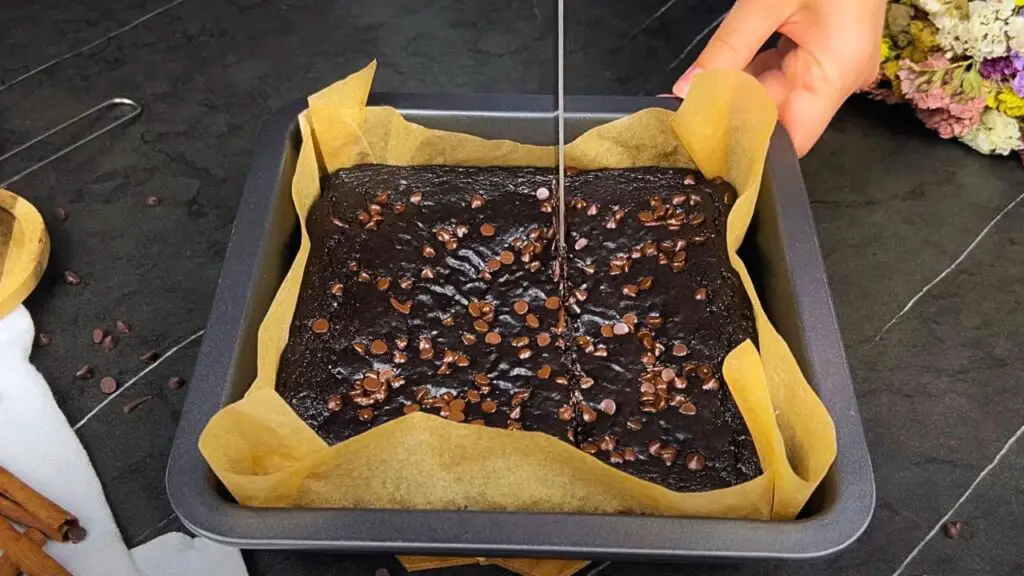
[167,94,874,562]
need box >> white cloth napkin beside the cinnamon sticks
[0,306,247,576]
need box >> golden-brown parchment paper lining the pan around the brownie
[200,64,836,520]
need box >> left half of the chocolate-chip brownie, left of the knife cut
[276,166,569,444]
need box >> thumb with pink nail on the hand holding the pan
[672,0,792,97]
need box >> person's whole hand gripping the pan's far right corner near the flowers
[672,0,886,157]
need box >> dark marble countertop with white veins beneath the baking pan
[0,0,1024,576]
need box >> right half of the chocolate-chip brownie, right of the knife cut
[565,168,761,492]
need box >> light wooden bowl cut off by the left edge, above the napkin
[0,189,50,318]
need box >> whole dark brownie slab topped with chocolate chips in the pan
[276,165,761,491]
